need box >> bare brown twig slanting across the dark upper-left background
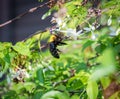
[0,0,54,28]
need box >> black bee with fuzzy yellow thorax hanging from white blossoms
[49,34,66,58]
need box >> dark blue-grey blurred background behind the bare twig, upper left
[0,0,51,43]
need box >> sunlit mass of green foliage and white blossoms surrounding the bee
[0,0,120,99]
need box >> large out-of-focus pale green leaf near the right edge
[91,48,116,80]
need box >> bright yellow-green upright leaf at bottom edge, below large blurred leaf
[86,80,98,99]
